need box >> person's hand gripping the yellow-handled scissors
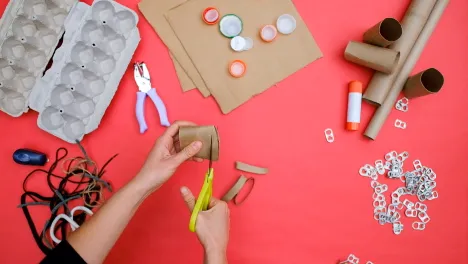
[180,187,229,254]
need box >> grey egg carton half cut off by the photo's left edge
[0,0,78,117]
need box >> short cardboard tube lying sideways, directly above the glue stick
[345,41,400,73]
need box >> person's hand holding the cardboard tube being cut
[135,121,203,192]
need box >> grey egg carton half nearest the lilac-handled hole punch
[29,0,140,143]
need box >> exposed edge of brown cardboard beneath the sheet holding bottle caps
[138,0,210,97]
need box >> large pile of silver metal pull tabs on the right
[359,151,439,235]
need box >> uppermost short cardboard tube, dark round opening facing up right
[364,17,403,47]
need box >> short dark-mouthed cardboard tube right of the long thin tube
[403,68,444,99]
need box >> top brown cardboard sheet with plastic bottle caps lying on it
[166,0,322,114]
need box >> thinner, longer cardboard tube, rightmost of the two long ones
[364,0,449,140]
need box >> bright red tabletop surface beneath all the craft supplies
[0,0,468,264]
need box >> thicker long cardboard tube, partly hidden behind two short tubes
[363,0,437,105]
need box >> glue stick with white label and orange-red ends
[346,81,362,131]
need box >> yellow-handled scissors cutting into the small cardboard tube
[189,138,214,232]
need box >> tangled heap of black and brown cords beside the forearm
[18,142,117,254]
